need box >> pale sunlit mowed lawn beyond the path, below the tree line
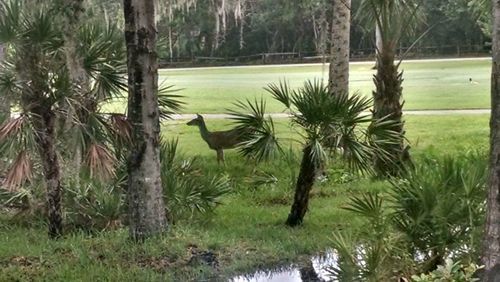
[155,58,491,113]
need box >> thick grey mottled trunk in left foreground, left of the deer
[123,0,167,241]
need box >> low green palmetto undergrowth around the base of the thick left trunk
[0,138,231,230]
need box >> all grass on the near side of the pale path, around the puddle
[0,115,488,281]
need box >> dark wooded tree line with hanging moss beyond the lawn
[90,0,491,60]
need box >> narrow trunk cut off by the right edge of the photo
[481,0,500,282]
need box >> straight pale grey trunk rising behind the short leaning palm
[328,0,351,95]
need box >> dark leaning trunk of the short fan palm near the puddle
[286,145,317,227]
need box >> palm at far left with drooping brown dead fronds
[0,0,129,238]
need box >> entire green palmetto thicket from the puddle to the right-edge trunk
[331,153,487,281]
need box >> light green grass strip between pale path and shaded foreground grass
[162,114,489,159]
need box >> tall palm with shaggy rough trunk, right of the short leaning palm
[358,0,419,175]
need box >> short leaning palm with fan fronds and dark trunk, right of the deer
[247,81,399,226]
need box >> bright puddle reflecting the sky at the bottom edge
[229,251,337,282]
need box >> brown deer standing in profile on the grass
[187,114,243,164]
